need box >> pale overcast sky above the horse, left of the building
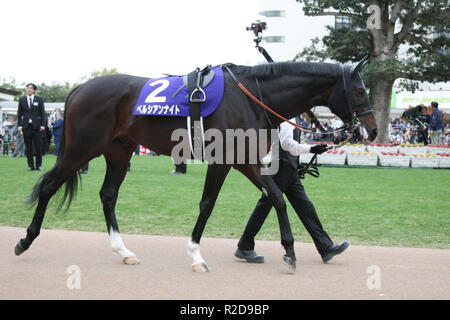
[0,0,258,84]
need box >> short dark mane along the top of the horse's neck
[230,62,341,78]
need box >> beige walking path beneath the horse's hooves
[0,227,450,299]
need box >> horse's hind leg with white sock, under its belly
[100,141,139,264]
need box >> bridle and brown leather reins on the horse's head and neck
[224,64,374,148]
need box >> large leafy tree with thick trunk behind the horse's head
[294,0,450,142]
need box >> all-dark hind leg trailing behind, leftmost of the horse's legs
[14,157,83,255]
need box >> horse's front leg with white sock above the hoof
[188,164,231,272]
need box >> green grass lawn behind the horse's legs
[0,155,450,249]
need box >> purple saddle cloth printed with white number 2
[133,66,224,117]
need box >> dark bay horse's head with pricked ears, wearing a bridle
[328,56,378,141]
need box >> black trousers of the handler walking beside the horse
[238,161,333,255]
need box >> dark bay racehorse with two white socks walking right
[15,62,377,272]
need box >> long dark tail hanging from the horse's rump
[27,86,81,212]
